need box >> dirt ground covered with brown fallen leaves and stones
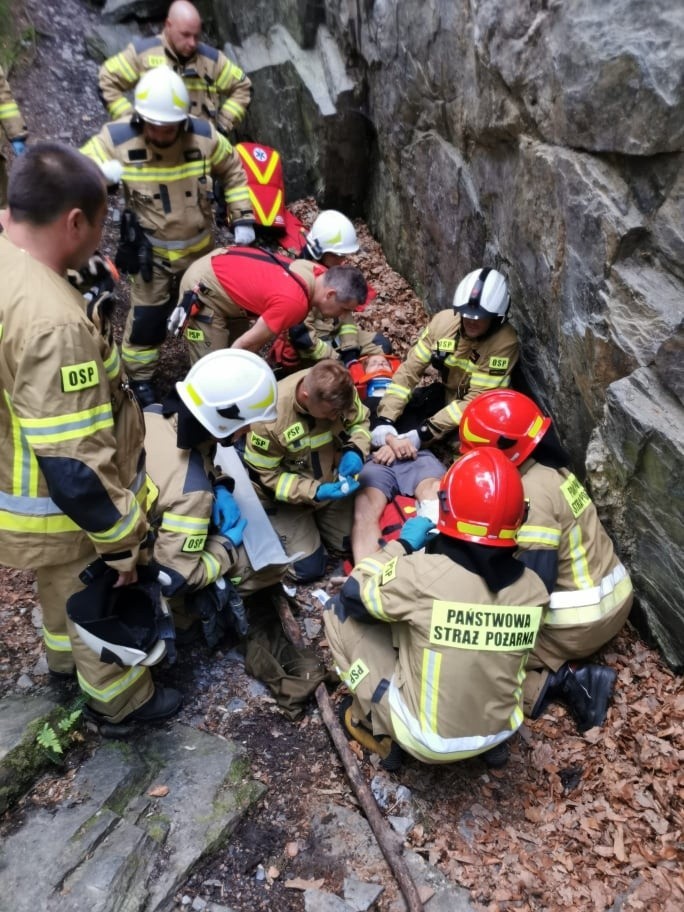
[0,0,684,912]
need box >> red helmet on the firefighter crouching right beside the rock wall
[458,390,551,465]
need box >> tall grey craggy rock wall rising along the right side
[213,0,684,669]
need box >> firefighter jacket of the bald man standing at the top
[98,33,252,133]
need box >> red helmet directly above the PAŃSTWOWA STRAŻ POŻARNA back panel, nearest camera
[437,447,526,548]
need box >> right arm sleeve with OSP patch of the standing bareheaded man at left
[12,323,147,573]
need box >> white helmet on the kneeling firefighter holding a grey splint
[176,348,278,440]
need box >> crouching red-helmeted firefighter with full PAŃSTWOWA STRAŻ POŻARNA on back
[324,448,549,769]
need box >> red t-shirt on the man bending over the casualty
[211,247,325,335]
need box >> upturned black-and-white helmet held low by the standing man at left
[66,561,175,667]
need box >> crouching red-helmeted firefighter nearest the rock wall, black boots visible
[459,390,633,732]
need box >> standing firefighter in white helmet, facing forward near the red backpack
[82,66,254,407]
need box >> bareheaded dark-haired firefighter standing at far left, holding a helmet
[0,143,181,722]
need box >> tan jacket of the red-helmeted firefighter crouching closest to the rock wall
[517,459,632,626]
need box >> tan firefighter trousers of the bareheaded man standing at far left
[36,552,154,723]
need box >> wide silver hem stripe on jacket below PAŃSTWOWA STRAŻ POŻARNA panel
[389,678,519,763]
